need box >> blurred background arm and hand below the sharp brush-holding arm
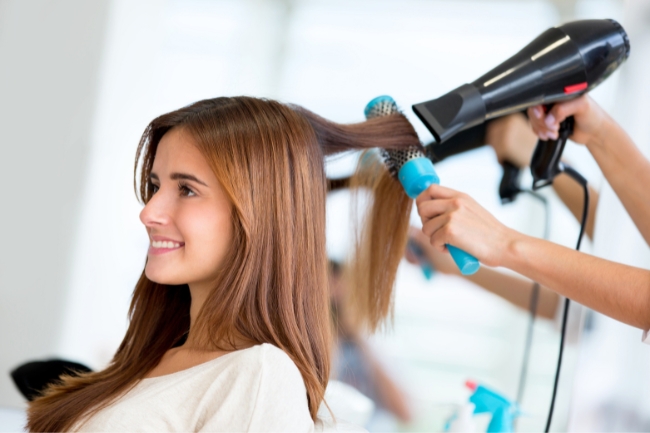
[407,227,560,319]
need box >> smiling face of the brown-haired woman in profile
[140,128,232,296]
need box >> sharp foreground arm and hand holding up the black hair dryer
[529,96,650,245]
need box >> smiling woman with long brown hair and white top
[28,97,419,431]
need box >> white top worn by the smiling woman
[73,344,354,432]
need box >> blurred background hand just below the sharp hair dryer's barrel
[485,113,537,168]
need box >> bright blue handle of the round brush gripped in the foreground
[398,157,481,275]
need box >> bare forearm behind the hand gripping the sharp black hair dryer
[587,121,650,245]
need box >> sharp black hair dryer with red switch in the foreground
[413,19,630,189]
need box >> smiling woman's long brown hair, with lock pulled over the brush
[27,97,419,431]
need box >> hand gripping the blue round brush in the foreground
[416,185,519,266]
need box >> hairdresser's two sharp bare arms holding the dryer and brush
[417,96,650,330]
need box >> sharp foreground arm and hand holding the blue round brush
[417,185,650,329]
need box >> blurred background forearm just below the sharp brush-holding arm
[465,266,559,319]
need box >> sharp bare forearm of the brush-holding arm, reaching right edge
[501,233,650,329]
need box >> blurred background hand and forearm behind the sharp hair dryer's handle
[485,113,598,239]
